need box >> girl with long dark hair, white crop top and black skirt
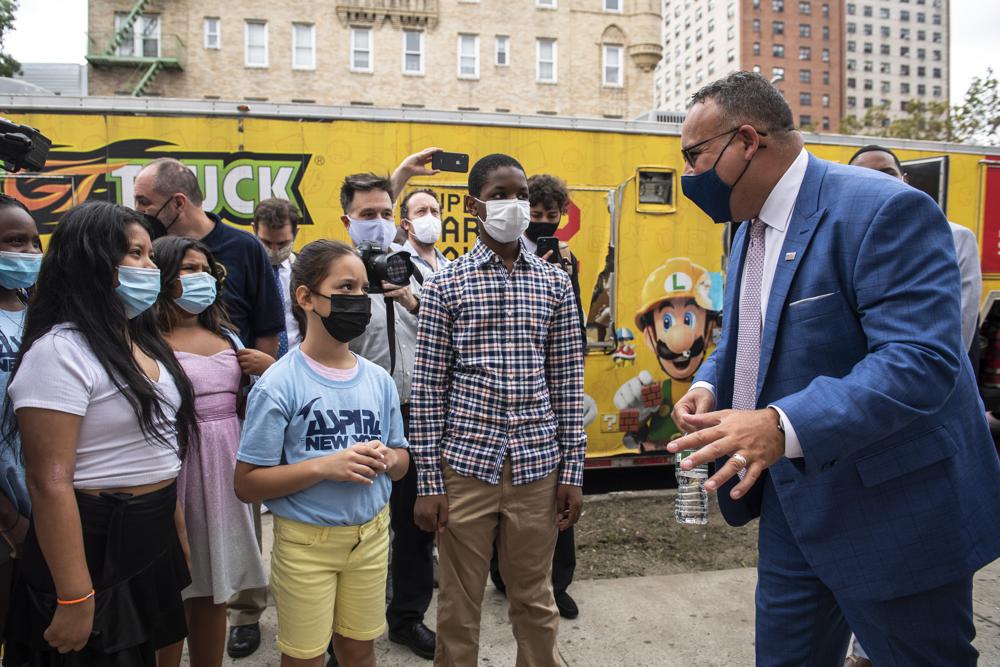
[4,202,198,667]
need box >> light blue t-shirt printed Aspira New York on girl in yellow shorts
[236,347,407,526]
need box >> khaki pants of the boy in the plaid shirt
[434,460,560,667]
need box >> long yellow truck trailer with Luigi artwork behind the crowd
[7,96,1000,467]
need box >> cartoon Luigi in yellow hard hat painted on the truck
[614,257,722,451]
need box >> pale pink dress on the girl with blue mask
[175,350,267,604]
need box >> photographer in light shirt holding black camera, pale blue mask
[340,168,436,659]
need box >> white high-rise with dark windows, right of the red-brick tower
[844,0,949,117]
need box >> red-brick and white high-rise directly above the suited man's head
[655,0,844,132]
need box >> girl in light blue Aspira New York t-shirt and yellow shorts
[235,241,409,667]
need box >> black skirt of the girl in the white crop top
[4,484,191,667]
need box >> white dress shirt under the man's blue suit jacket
[689,148,809,458]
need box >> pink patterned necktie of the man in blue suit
[733,220,764,479]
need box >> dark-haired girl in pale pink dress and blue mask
[153,236,266,667]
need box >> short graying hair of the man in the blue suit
[689,72,795,134]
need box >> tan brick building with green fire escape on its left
[87,0,664,118]
